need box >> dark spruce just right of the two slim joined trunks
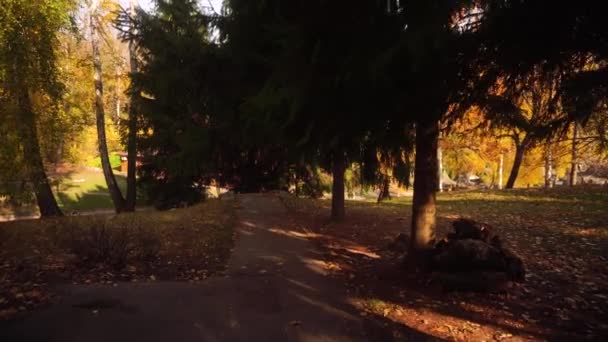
[123,0,228,208]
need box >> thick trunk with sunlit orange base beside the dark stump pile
[409,120,439,260]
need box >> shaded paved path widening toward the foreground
[0,194,426,342]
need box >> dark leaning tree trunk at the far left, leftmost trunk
[17,87,63,217]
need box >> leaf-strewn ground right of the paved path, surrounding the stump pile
[283,186,608,341]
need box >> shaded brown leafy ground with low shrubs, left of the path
[0,200,235,318]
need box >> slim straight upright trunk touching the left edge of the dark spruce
[125,0,138,211]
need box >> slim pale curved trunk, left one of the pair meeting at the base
[89,5,125,212]
